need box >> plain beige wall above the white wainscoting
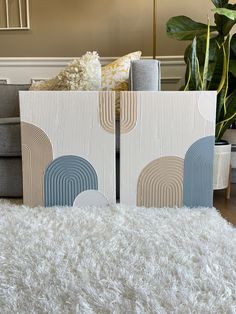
[0,0,216,57]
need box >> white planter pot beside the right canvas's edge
[213,144,231,190]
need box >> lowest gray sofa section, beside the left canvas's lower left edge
[0,157,23,197]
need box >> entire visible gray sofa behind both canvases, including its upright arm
[0,60,160,199]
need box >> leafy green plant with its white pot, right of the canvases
[167,0,236,193]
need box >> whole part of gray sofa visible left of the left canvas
[0,84,29,197]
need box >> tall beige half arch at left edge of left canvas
[21,122,53,207]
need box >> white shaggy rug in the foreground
[0,204,236,314]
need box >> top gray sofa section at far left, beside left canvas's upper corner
[0,84,30,118]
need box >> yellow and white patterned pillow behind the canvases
[102,51,142,91]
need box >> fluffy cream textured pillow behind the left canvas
[30,52,101,91]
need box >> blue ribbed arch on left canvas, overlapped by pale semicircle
[44,155,98,207]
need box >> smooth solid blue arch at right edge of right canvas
[183,136,215,207]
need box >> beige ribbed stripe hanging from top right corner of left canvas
[99,92,116,133]
